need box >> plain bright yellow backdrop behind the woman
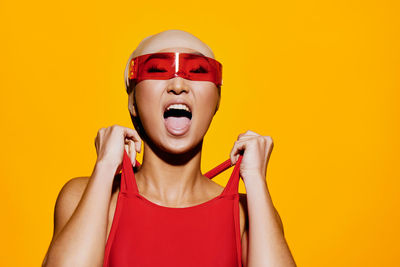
[0,0,400,267]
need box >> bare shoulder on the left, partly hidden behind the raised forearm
[53,176,90,239]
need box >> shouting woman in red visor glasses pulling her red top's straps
[43,30,296,267]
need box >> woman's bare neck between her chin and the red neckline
[135,141,204,205]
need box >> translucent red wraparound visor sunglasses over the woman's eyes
[129,52,222,87]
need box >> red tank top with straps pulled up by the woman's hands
[103,152,243,267]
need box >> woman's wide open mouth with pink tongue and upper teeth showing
[164,104,192,135]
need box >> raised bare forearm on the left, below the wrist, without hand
[45,163,116,267]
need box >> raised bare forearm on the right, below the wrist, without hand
[246,177,296,267]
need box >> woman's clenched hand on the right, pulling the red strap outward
[230,131,274,183]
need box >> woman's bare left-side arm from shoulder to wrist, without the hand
[42,162,117,267]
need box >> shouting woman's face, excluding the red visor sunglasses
[129,48,220,154]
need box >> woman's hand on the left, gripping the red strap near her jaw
[94,124,142,174]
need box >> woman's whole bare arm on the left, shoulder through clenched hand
[43,125,141,267]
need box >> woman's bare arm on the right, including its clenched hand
[231,131,296,267]
